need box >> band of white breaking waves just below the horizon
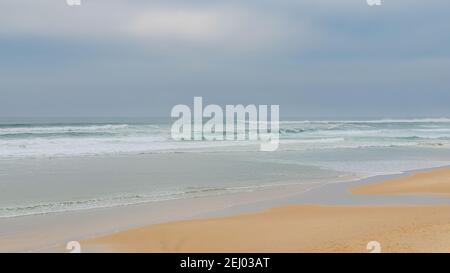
[0,118,450,158]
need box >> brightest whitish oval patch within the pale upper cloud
[127,7,300,50]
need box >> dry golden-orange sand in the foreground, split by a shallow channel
[82,168,450,252]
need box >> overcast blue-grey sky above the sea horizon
[0,0,450,118]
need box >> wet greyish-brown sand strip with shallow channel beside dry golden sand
[0,167,450,252]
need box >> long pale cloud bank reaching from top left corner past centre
[0,0,310,50]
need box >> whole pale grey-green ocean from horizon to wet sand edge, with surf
[0,118,450,218]
